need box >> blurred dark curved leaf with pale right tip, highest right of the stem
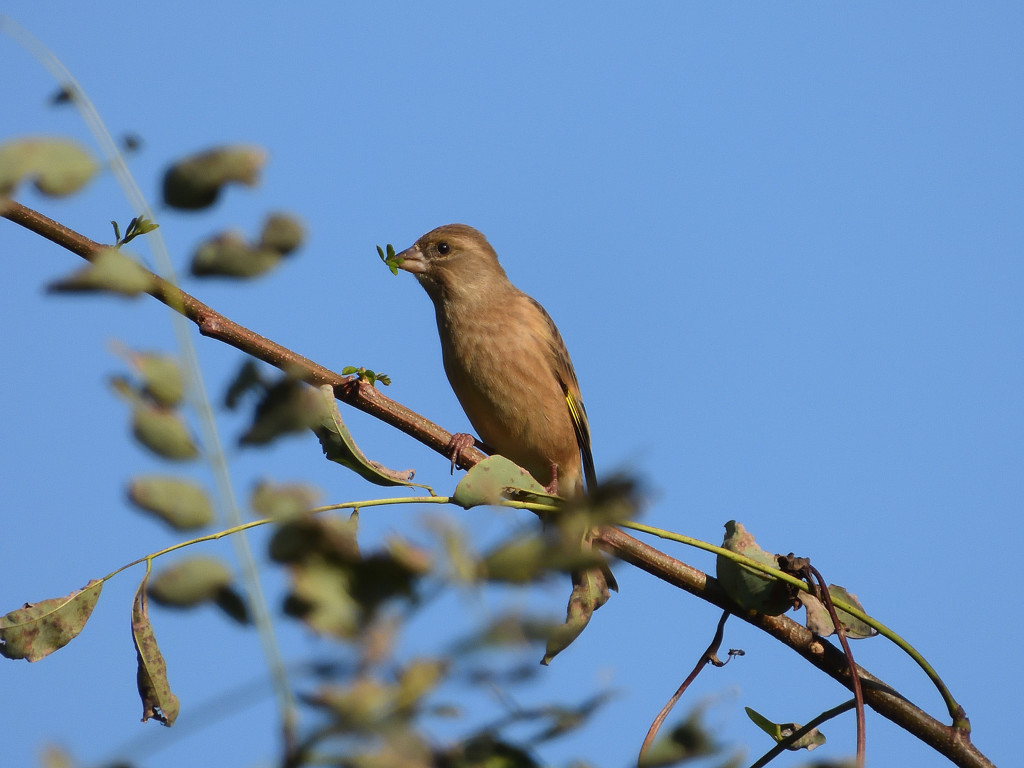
[164,144,266,210]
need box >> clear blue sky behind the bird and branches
[0,6,1024,768]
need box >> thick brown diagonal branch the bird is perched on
[0,201,994,768]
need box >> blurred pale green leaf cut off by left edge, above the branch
[0,138,99,198]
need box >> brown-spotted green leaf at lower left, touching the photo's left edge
[0,579,103,662]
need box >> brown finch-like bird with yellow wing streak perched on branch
[396,224,617,607]
